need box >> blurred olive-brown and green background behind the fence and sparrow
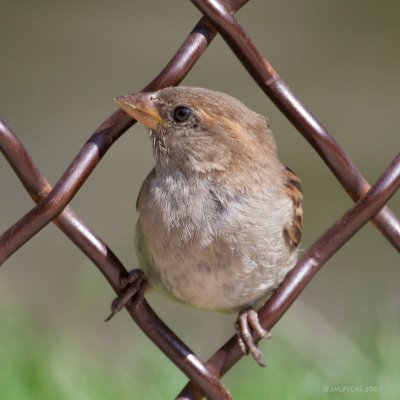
[0,0,400,400]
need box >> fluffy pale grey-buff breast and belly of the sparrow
[139,173,293,309]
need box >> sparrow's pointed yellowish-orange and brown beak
[114,92,167,129]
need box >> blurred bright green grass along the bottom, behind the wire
[0,304,400,400]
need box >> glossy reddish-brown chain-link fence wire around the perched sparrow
[0,0,400,399]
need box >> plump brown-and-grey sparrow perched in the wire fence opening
[112,87,303,365]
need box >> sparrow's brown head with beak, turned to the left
[115,86,276,178]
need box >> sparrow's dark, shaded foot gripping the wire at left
[105,269,147,322]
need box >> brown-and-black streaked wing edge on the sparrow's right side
[283,167,303,249]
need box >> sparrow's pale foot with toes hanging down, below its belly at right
[236,307,271,367]
